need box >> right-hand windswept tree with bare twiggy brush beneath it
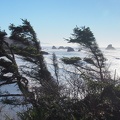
[61,27,113,104]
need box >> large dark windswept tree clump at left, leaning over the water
[0,19,58,108]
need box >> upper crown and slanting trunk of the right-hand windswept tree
[63,26,107,81]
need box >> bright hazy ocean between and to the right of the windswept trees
[43,47,120,77]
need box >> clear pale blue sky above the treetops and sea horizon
[0,0,120,47]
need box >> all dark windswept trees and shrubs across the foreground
[0,19,120,120]
